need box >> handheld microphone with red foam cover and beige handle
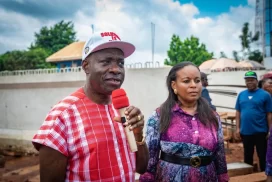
[112,89,138,152]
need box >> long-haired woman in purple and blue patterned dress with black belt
[140,62,229,182]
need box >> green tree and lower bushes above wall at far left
[0,21,76,71]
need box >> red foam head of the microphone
[111,88,129,109]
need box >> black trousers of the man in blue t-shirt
[241,133,267,171]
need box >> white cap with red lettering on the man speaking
[82,32,135,61]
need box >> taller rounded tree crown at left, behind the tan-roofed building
[30,20,76,55]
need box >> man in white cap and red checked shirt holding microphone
[33,32,151,182]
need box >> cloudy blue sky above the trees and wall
[0,0,255,64]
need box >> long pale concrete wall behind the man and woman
[0,67,267,151]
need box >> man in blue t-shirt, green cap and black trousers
[235,71,272,171]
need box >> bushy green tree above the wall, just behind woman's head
[164,34,213,66]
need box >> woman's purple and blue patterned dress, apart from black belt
[140,104,229,182]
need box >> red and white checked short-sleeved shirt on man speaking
[32,88,135,182]
